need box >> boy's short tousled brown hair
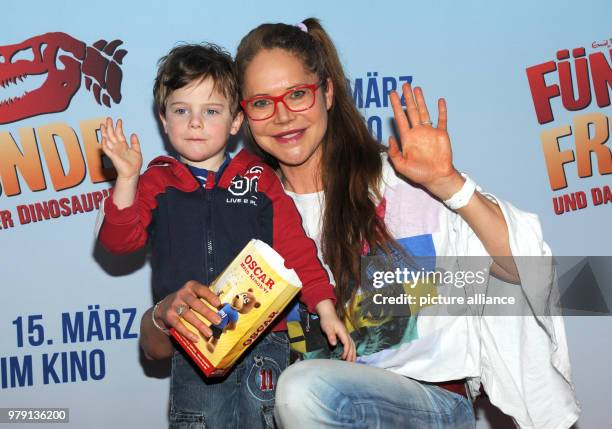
[153,43,239,116]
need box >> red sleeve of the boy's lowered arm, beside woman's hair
[258,167,336,313]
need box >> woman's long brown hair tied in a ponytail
[236,18,394,316]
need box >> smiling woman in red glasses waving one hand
[236,19,577,428]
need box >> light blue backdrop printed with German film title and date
[0,0,612,428]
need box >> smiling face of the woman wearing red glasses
[242,49,333,168]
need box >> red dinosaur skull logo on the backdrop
[0,33,127,124]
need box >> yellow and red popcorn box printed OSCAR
[170,240,302,376]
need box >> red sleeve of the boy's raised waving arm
[98,157,198,253]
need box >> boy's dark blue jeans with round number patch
[170,332,289,429]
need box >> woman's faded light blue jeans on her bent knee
[275,359,476,429]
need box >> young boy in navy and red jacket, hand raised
[99,45,354,428]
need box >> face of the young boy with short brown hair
[159,78,242,171]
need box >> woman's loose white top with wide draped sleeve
[292,159,580,429]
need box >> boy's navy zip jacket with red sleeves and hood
[99,150,335,330]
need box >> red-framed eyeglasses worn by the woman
[240,82,323,121]
